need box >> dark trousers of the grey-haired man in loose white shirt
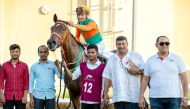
[114,102,140,109]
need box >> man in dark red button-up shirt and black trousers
[0,44,29,109]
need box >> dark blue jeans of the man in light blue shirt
[34,98,55,109]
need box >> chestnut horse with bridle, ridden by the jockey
[47,14,84,109]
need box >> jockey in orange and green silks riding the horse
[68,5,105,54]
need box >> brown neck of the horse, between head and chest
[63,32,80,62]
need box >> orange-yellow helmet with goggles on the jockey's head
[76,5,90,15]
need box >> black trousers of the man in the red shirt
[3,100,26,109]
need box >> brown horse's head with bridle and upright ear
[47,14,68,51]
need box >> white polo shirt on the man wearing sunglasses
[144,53,186,98]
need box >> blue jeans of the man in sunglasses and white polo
[150,98,181,109]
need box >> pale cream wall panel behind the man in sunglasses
[135,0,174,60]
